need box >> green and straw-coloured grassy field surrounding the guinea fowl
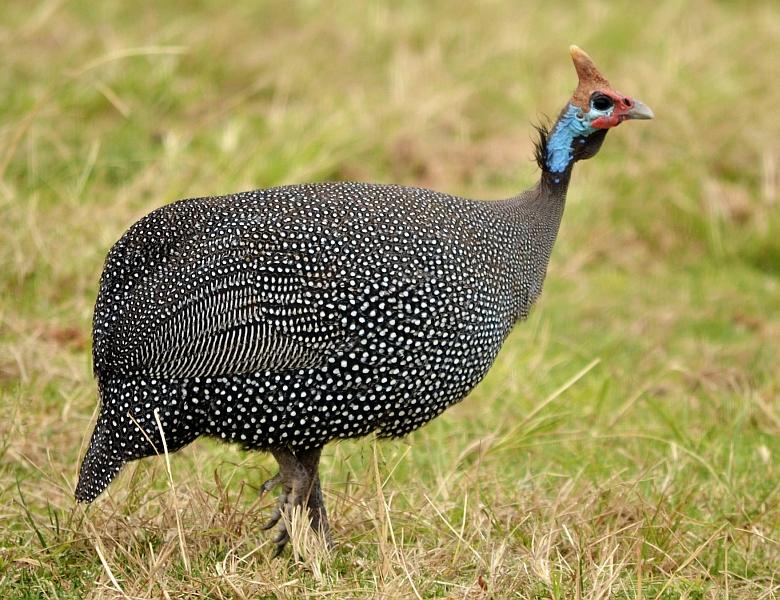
[0,0,780,600]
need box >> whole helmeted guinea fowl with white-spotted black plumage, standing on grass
[76,46,653,553]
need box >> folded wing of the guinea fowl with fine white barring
[93,202,352,378]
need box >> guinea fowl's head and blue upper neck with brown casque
[537,46,653,174]
